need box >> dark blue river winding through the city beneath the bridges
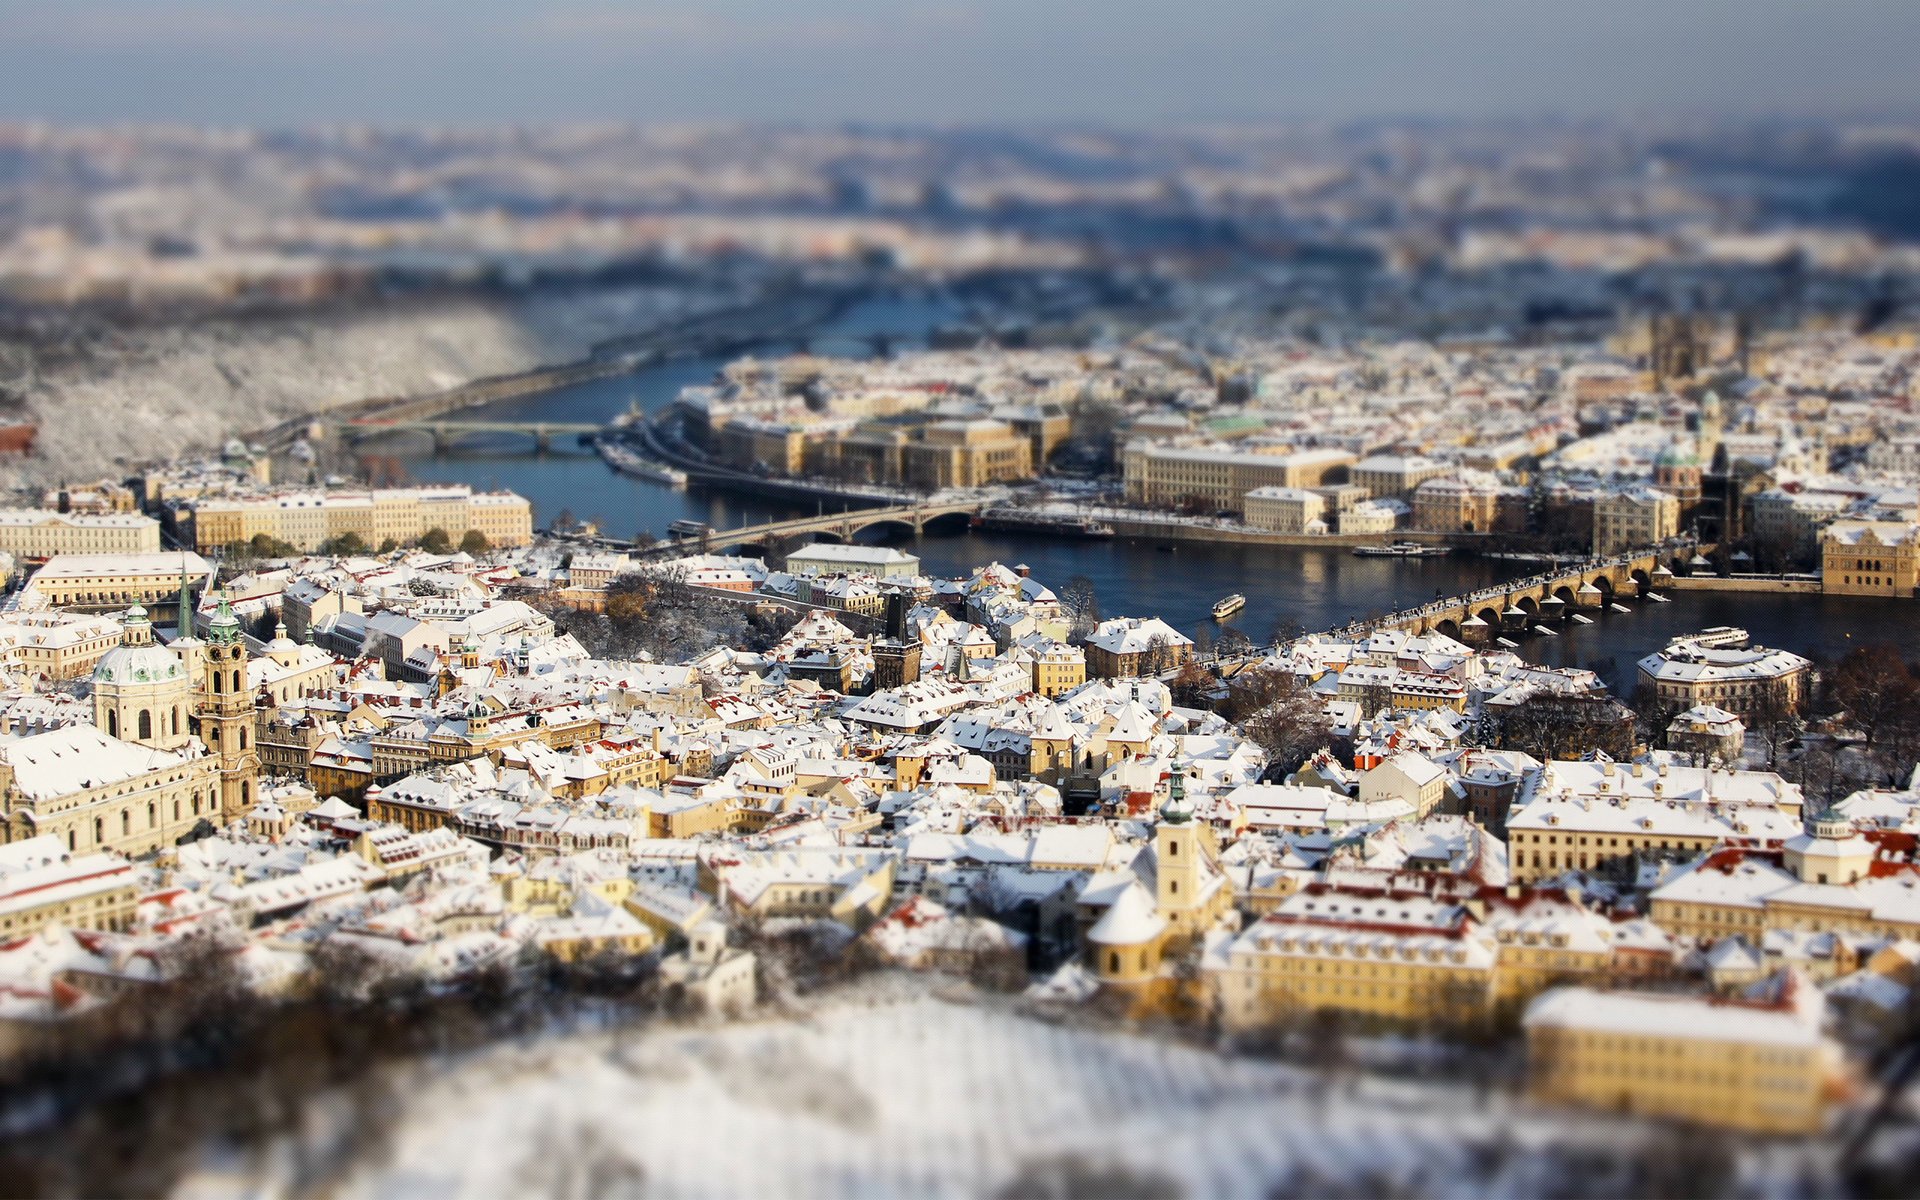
[378,288,1920,689]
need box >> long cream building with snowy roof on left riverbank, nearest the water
[194,486,534,551]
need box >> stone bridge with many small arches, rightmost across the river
[1342,545,1695,641]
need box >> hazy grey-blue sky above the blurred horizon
[0,0,1920,127]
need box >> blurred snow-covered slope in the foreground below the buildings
[236,995,1809,1200]
